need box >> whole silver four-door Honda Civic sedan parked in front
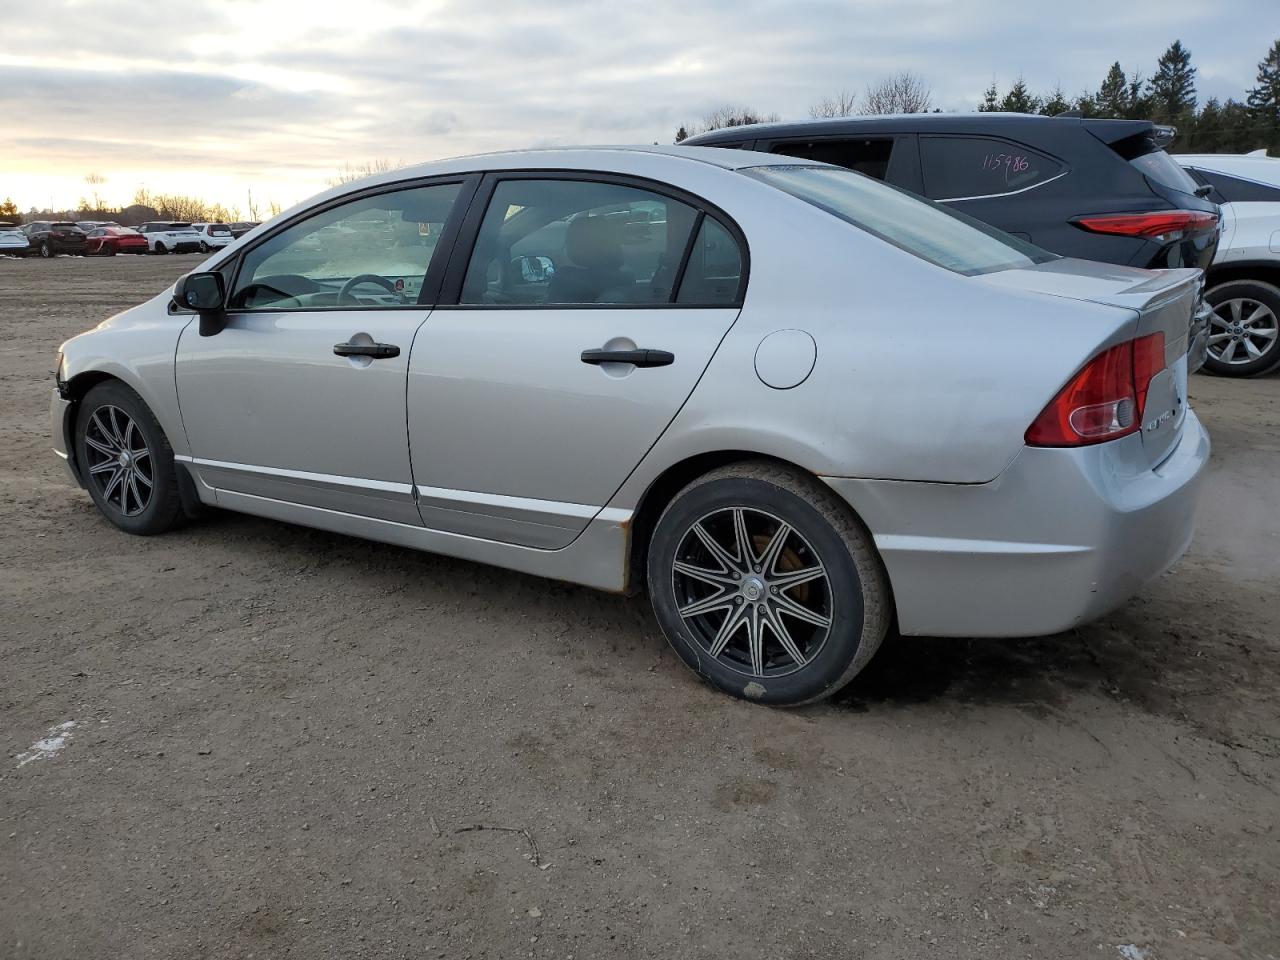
[52,147,1210,704]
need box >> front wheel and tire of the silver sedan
[74,380,183,536]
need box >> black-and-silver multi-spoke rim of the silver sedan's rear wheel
[671,507,832,677]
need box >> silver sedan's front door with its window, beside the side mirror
[177,179,475,525]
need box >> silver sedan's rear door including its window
[408,174,746,548]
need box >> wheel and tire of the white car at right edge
[1204,280,1280,376]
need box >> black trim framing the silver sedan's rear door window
[435,168,751,311]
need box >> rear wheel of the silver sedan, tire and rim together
[646,462,891,707]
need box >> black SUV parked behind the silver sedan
[684,113,1219,269]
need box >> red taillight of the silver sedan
[1027,333,1165,447]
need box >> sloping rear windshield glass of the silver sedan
[745,166,1056,276]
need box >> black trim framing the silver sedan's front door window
[217,173,481,316]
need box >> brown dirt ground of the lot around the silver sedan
[0,256,1280,960]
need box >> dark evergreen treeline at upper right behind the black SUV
[978,40,1280,154]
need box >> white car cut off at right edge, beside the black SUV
[1178,150,1280,376]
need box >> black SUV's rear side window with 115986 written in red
[920,137,1064,200]
